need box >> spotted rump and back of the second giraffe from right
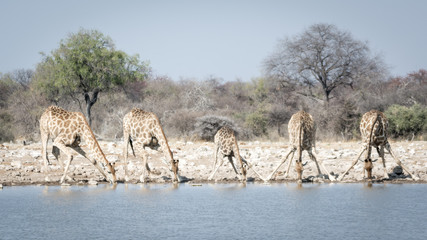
[288,111,316,150]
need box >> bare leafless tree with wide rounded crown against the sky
[264,24,382,103]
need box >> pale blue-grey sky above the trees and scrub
[0,0,427,81]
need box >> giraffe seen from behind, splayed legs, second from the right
[267,111,335,183]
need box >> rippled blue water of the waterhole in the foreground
[0,183,427,239]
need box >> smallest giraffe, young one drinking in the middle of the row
[208,126,264,181]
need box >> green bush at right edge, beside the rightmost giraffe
[385,104,427,137]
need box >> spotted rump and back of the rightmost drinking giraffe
[360,110,388,146]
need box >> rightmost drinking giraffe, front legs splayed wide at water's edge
[338,110,418,181]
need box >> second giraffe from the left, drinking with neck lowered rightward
[123,108,181,182]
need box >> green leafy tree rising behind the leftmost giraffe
[35,29,149,125]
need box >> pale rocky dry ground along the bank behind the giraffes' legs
[0,140,427,186]
